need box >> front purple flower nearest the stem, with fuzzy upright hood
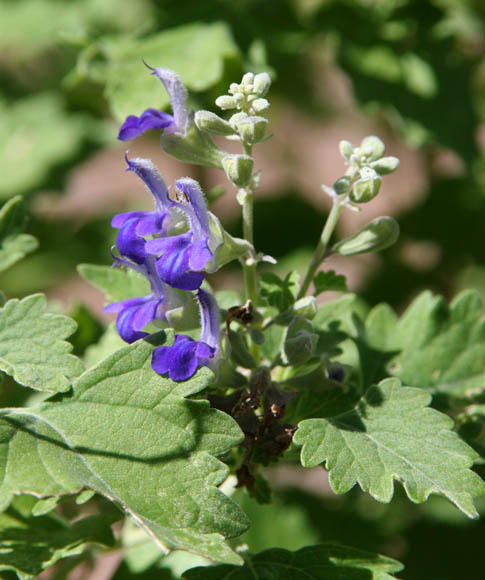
[145,177,220,290]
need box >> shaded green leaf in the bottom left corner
[0,508,114,580]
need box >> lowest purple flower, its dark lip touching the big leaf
[152,290,220,381]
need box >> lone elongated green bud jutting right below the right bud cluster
[332,216,399,256]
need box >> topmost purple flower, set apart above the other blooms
[118,63,189,141]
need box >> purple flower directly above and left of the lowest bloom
[103,257,183,343]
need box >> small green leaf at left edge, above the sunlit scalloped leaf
[0,196,38,272]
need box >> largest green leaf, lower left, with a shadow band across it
[0,332,248,563]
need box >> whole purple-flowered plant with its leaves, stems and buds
[0,64,485,580]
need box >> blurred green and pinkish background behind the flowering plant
[0,0,485,580]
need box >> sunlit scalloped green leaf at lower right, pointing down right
[294,378,485,518]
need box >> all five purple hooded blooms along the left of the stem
[104,67,224,381]
